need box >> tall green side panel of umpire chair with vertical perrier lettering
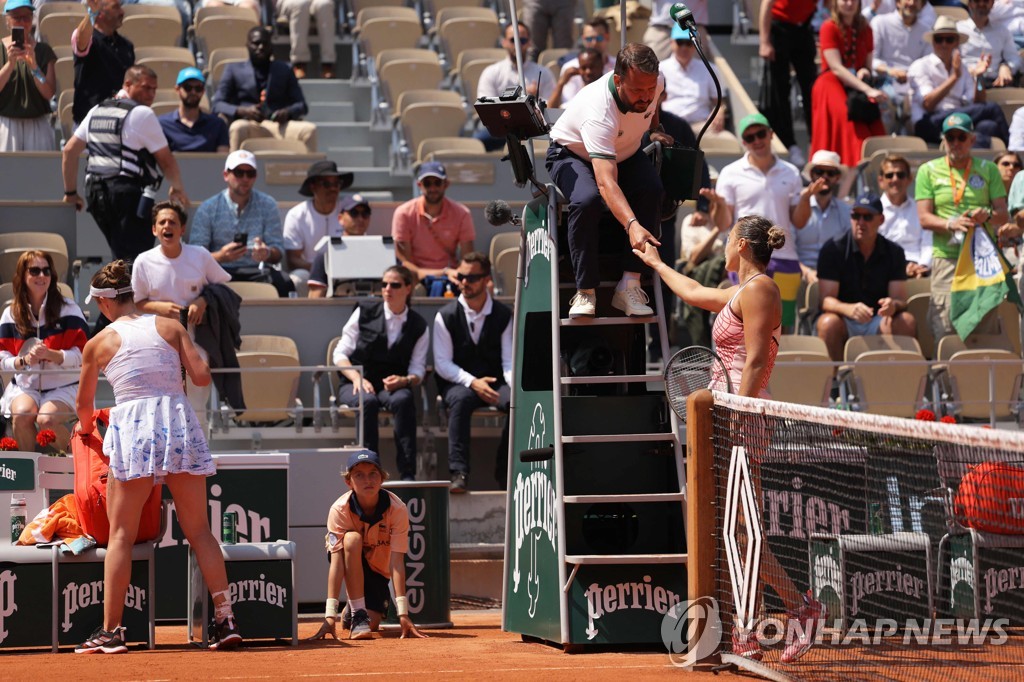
[504,197,562,642]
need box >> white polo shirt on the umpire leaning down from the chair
[551,74,665,163]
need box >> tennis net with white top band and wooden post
[687,392,1024,680]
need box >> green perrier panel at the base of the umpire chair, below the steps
[569,564,686,644]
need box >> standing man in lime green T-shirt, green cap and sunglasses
[913,111,1021,339]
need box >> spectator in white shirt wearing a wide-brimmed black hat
[284,161,354,296]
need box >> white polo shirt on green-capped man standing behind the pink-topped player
[715,154,804,260]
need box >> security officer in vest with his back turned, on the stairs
[60,66,188,260]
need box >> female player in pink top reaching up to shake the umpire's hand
[634,215,826,663]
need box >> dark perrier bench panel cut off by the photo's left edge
[0,547,53,649]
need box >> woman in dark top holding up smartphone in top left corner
[0,0,57,152]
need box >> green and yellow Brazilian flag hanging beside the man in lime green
[949,226,1024,339]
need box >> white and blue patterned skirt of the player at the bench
[103,393,216,483]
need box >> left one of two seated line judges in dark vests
[331,265,430,480]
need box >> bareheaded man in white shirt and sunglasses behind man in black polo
[879,155,932,279]
